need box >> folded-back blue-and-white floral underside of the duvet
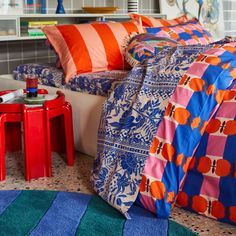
[91,43,210,215]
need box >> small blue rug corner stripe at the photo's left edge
[0,190,21,214]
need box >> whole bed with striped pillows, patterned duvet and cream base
[1,14,236,224]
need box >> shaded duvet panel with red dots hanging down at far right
[177,81,236,224]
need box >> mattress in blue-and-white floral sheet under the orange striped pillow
[13,64,128,97]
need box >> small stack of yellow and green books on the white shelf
[28,21,58,36]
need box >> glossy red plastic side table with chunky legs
[0,90,74,181]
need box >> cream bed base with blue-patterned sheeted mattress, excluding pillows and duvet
[0,64,128,157]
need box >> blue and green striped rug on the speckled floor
[0,190,195,236]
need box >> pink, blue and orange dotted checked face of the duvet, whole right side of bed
[138,43,236,221]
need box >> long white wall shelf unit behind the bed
[0,14,166,41]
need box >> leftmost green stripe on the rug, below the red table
[0,190,57,236]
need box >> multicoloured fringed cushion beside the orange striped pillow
[125,33,178,67]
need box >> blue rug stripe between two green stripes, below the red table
[30,192,92,236]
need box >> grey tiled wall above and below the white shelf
[0,0,159,74]
